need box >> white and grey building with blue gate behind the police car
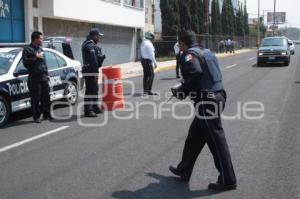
[0,0,145,64]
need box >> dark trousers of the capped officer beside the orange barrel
[84,74,99,113]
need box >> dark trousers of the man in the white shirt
[142,59,154,92]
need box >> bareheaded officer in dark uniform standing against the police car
[22,32,51,123]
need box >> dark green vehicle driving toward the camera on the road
[257,37,292,66]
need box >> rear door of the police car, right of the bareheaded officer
[45,50,68,100]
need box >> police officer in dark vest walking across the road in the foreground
[169,31,237,190]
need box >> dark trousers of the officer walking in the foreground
[177,94,236,184]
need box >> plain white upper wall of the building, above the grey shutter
[40,0,145,28]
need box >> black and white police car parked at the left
[0,47,82,127]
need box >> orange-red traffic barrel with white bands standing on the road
[102,66,125,111]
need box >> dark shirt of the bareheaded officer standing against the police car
[22,43,48,77]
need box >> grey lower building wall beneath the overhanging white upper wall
[43,18,137,65]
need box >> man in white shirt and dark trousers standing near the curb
[141,32,157,95]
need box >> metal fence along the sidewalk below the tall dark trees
[153,35,256,57]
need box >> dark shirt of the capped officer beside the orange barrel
[81,39,103,73]
